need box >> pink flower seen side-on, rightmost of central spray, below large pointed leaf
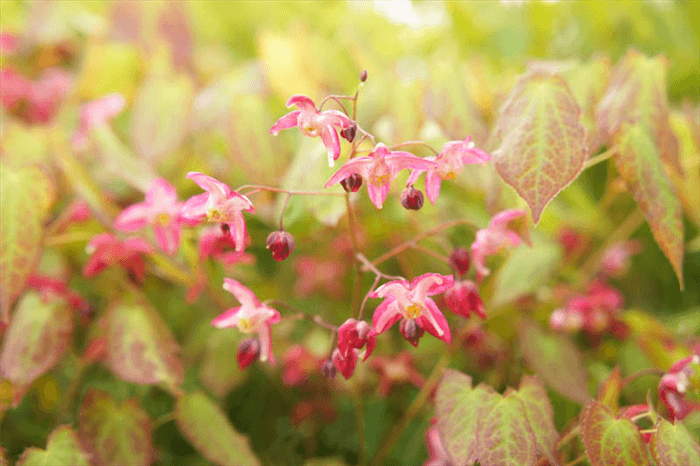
[472,209,526,281]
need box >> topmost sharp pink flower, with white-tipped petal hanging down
[270,95,352,167]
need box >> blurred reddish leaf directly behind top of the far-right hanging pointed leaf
[596,50,683,173]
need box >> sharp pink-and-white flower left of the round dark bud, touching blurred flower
[180,172,255,251]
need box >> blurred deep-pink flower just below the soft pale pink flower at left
[83,233,153,281]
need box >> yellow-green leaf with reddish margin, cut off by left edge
[0,163,53,323]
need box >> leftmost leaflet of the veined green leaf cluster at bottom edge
[435,370,498,465]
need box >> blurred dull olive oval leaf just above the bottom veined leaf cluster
[518,320,590,403]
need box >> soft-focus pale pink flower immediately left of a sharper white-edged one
[114,178,193,254]
